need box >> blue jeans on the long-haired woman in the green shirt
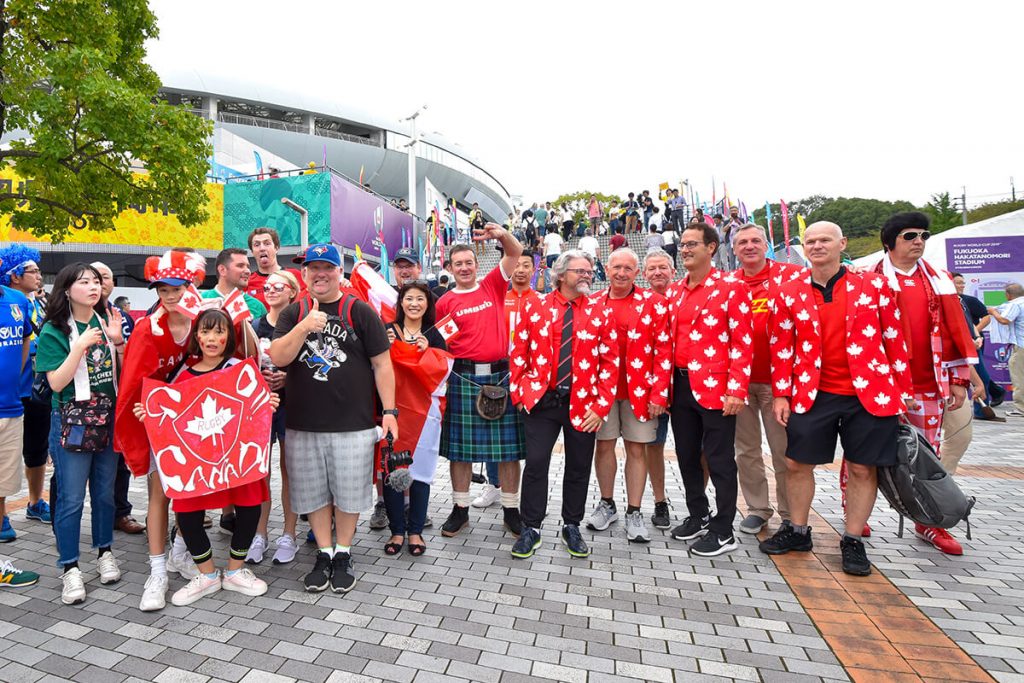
[50,411,118,566]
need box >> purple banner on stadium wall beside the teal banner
[331,176,413,258]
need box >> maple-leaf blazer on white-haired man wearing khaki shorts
[591,287,672,422]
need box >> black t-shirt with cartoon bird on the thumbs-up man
[273,297,390,432]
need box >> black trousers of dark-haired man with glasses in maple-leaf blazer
[672,368,739,537]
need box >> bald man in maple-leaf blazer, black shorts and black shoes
[760,221,915,575]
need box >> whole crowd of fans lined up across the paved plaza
[0,206,1011,611]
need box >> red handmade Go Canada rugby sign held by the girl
[142,358,273,500]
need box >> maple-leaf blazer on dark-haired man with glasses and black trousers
[667,268,754,411]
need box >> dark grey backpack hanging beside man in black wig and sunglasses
[878,424,975,540]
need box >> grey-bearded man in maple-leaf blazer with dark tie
[509,249,618,558]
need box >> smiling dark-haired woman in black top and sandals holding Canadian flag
[384,281,447,557]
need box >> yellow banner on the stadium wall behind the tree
[0,169,224,250]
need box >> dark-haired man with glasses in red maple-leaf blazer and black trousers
[667,223,754,557]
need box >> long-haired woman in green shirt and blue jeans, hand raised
[36,263,125,605]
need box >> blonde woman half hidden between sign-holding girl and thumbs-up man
[246,269,300,564]
